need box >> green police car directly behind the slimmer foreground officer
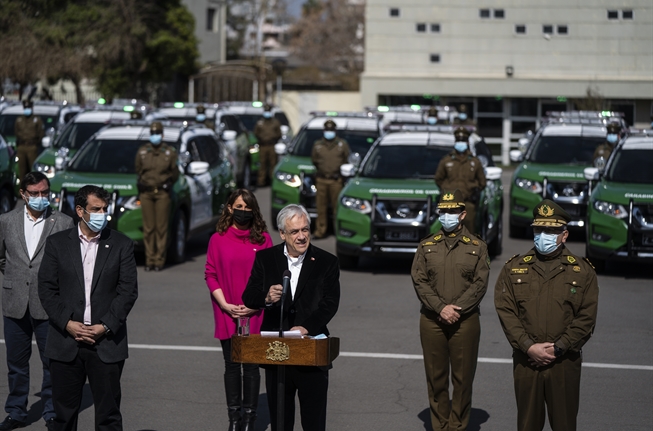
[336,126,503,268]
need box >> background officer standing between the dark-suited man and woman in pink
[136,121,179,271]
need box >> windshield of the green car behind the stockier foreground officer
[529,136,605,166]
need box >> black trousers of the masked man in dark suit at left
[50,345,125,431]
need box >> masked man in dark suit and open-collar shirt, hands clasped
[39,186,138,431]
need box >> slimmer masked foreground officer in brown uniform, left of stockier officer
[411,190,490,430]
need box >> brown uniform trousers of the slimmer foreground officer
[419,312,481,431]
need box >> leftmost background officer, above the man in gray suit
[14,100,44,186]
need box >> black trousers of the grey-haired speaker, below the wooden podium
[265,366,329,431]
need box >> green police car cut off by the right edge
[585,130,653,270]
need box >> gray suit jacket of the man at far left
[0,205,74,320]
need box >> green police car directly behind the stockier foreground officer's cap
[510,121,607,237]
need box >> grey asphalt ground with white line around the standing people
[0,173,653,431]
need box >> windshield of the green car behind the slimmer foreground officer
[361,145,451,179]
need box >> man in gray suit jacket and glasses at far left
[0,172,74,430]
